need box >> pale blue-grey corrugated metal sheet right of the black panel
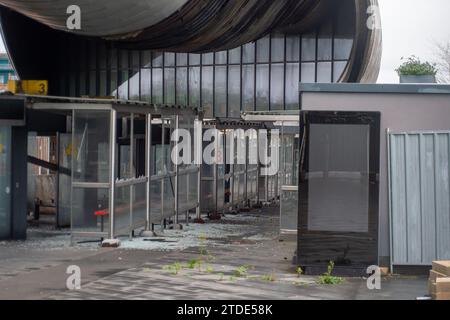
[388,131,450,265]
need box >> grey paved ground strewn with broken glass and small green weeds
[0,207,427,300]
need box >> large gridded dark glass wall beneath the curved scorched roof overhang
[53,7,355,117]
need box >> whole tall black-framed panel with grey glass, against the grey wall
[297,112,380,276]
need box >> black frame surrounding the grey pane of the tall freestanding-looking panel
[297,111,381,275]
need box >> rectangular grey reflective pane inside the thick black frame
[308,124,370,233]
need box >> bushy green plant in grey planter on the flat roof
[395,56,437,83]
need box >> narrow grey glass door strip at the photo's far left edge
[0,126,11,239]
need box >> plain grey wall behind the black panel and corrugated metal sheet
[301,87,450,263]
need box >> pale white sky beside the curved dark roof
[0,0,450,83]
